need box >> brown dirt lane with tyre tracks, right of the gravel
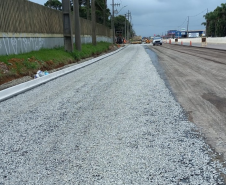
[149,44,226,160]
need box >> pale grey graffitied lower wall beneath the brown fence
[0,33,112,55]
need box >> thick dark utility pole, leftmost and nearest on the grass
[62,0,73,52]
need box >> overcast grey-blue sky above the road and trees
[30,0,226,36]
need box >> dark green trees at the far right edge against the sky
[202,3,226,37]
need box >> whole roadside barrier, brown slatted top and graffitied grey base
[0,0,112,55]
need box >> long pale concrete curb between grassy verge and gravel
[0,46,126,102]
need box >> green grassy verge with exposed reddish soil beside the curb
[0,42,112,85]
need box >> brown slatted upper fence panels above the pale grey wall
[0,0,111,37]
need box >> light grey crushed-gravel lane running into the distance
[0,45,226,185]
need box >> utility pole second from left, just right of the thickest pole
[74,0,82,51]
